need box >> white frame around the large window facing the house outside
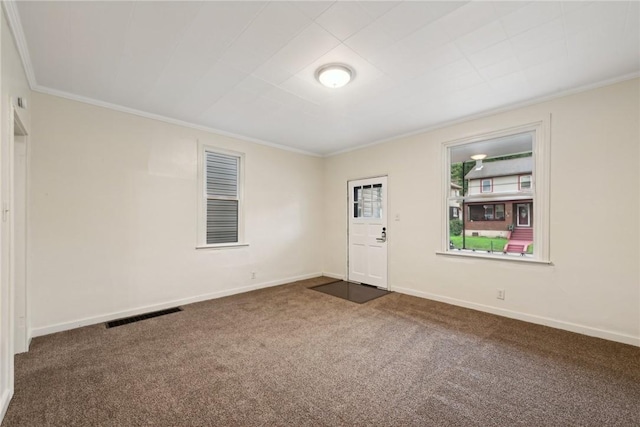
[436,115,551,264]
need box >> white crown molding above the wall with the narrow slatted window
[31,85,322,157]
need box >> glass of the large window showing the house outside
[447,132,535,257]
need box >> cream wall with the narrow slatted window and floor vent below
[29,93,323,336]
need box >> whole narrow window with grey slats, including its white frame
[198,145,243,247]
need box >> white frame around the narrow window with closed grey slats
[196,141,248,249]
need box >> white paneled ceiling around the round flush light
[8,1,640,155]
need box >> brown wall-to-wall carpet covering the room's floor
[2,278,640,427]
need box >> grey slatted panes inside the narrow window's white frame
[204,150,240,245]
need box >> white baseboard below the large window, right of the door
[393,287,640,347]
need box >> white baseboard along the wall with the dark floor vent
[29,273,322,344]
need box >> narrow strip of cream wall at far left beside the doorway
[0,4,30,420]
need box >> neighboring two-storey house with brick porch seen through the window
[464,157,534,247]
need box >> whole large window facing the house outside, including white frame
[439,121,549,262]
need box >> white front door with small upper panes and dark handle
[348,176,389,289]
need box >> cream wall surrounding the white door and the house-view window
[324,79,640,345]
